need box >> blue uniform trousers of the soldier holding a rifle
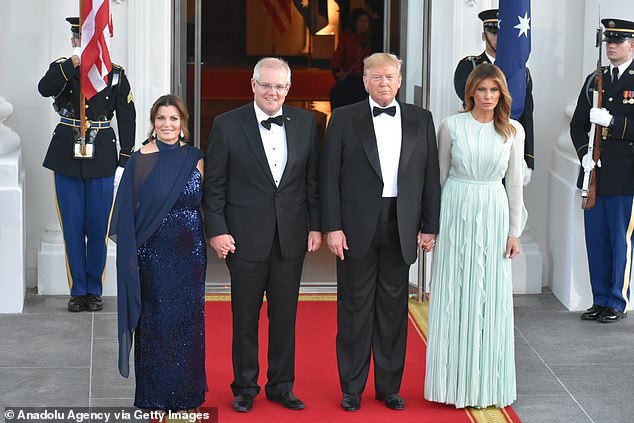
[584,195,634,311]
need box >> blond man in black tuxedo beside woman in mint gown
[320,53,440,411]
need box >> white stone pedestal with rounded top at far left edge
[0,97,26,313]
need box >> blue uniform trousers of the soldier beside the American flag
[55,172,114,296]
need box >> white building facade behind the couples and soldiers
[0,0,634,312]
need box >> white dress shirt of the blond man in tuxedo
[369,97,403,197]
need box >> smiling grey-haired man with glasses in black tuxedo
[204,58,321,412]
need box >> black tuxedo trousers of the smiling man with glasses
[227,234,304,397]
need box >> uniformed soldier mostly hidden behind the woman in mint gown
[454,9,535,186]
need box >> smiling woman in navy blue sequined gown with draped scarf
[110,95,207,410]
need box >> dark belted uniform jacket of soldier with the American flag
[38,58,136,178]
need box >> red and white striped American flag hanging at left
[81,0,113,99]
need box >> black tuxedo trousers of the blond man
[337,199,409,394]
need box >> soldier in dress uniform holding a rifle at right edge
[570,19,634,323]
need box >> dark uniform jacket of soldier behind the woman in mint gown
[454,52,535,169]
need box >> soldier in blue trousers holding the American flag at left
[38,17,136,312]
